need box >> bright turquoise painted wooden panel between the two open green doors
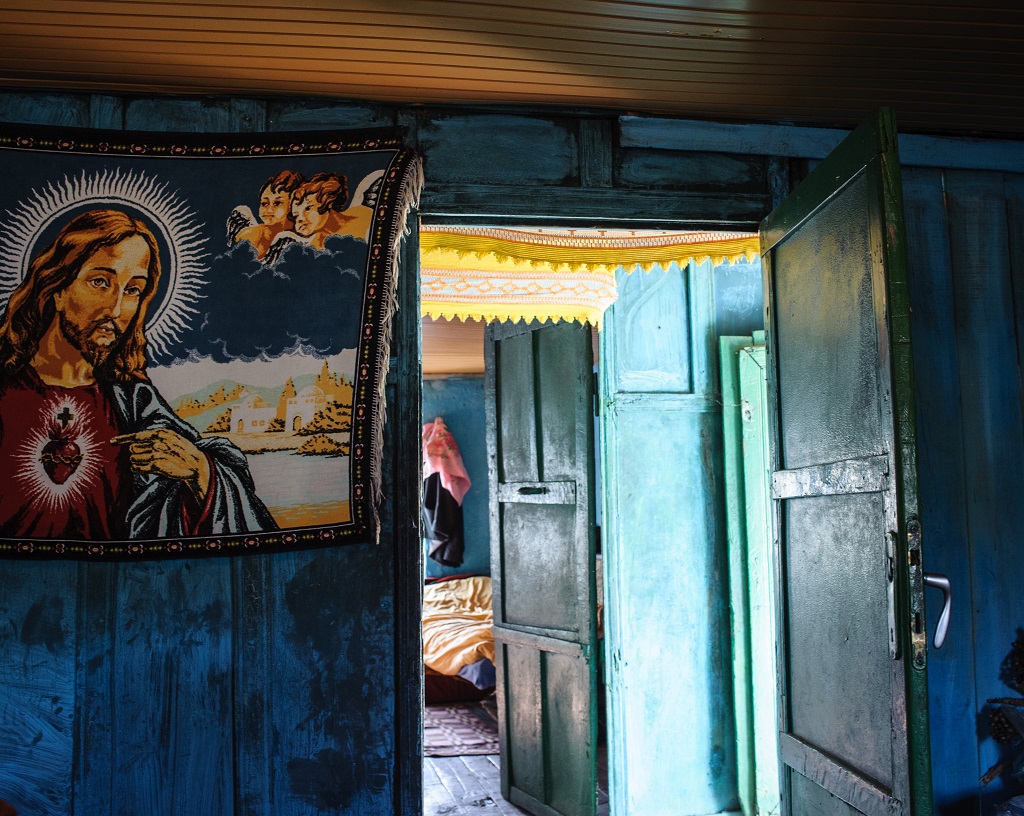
[601,264,737,816]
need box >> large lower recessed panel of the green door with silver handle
[783,492,892,787]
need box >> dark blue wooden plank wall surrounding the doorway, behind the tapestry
[0,86,1024,816]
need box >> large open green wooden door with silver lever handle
[761,112,932,816]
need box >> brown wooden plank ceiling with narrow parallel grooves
[0,0,1024,136]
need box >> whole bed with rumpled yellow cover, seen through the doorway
[423,575,495,703]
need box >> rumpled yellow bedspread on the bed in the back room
[423,575,495,676]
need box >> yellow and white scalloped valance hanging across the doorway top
[420,227,758,326]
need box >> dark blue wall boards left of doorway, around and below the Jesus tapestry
[0,95,407,816]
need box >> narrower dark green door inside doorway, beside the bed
[485,323,597,816]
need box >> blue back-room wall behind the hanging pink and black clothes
[423,377,490,576]
